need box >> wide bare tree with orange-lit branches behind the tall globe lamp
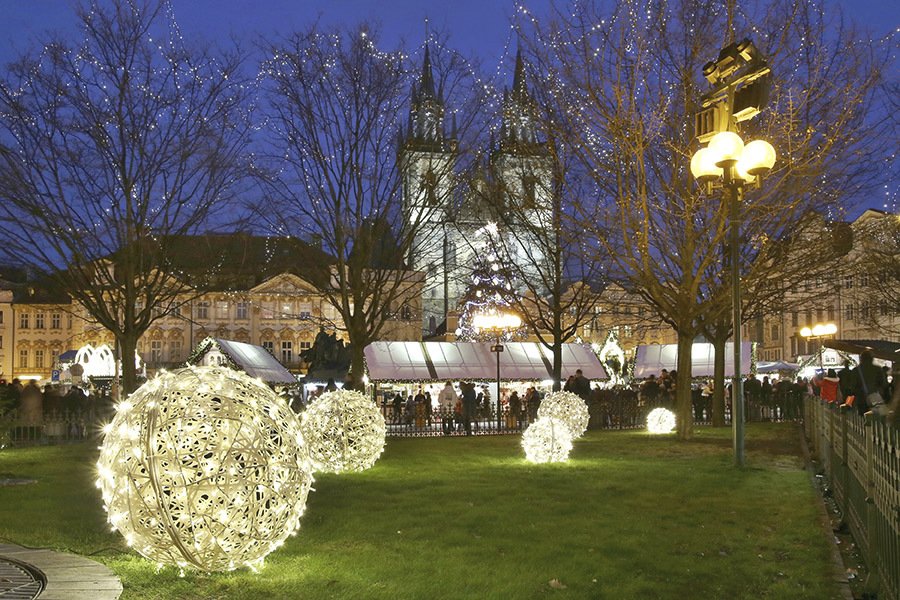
[529,0,881,439]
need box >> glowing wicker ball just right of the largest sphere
[301,390,386,473]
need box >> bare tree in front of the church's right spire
[476,52,603,390]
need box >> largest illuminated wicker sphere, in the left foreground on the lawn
[97,367,313,572]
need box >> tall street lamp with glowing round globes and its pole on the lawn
[691,131,775,467]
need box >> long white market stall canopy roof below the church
[365,342,606,381]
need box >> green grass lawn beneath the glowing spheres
[0,424,837,600]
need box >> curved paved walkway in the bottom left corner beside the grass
[0,544,122,600]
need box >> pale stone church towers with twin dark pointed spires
[398,45,553,338]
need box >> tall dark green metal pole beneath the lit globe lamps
[724,173,744,467]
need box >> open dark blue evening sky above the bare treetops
[0,0,900,68]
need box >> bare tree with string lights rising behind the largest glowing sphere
[0,0,248,391]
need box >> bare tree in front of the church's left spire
[260,25,488,377]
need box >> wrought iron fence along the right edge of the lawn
[803,397,900,598]
